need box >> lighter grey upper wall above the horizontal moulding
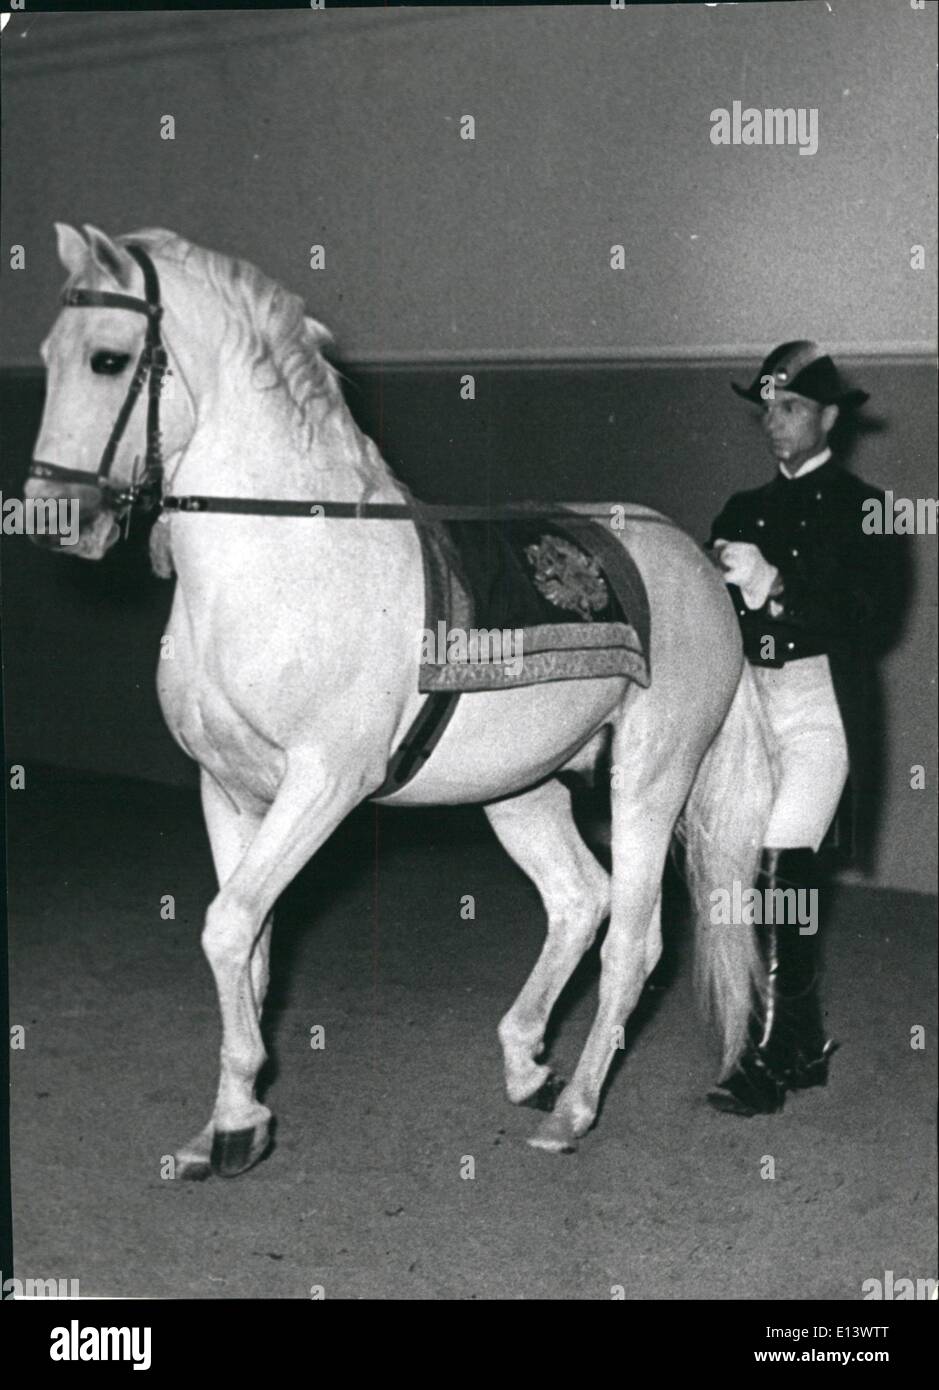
[0,0,936,364]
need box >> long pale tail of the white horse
[681,662,775,1076]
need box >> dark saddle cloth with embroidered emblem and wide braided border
[415,507,650,694]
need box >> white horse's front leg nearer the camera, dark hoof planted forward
[178,749,383,1177]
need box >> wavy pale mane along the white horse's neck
[118,227,374,463]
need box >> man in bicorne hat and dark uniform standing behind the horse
[708,342,900,1115]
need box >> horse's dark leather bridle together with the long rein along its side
[29,243,675,534]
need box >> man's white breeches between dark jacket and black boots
[753,656,847,851]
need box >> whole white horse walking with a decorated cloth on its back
[28,225,772,1177]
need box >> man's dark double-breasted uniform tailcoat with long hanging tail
[708,459,906,859]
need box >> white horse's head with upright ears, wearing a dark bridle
[25,222,193,560]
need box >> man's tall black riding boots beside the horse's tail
[707,849,835,1115]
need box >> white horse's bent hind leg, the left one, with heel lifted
[486,780,610,1109]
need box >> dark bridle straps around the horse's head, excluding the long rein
[29,245,167,520]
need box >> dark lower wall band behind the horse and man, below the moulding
[0,361,936,891]
